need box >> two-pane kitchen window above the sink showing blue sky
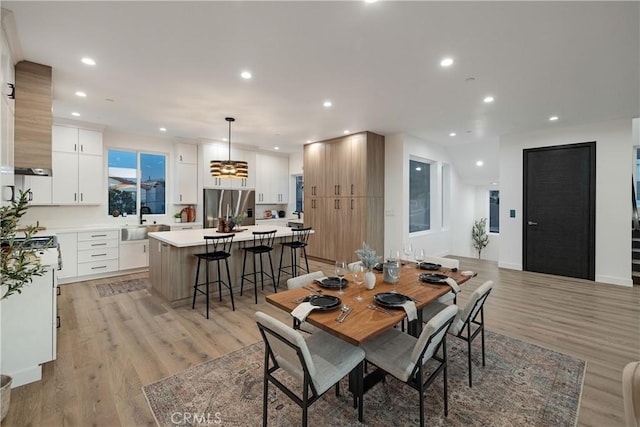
[108,150,167,215]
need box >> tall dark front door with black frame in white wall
[523,142,596,280]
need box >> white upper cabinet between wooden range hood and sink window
[52,126,105,205]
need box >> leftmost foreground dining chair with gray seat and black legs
[255,311,365,427]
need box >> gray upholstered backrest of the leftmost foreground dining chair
[255,311,316,384]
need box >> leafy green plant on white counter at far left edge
[0,190,46,299]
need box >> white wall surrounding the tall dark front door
[498,119,633,286]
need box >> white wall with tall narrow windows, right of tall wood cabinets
[376,134,474,256]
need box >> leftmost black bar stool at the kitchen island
[191,234,236,319]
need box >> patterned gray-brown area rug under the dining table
[142,331,586,427]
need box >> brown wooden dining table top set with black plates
[266,262,472,345]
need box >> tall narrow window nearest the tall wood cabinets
[409,160,431,233]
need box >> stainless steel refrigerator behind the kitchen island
[202,188,256,228]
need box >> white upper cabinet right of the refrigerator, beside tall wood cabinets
[255,153,289,204]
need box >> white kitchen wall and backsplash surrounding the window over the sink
[22,131,182,228]
